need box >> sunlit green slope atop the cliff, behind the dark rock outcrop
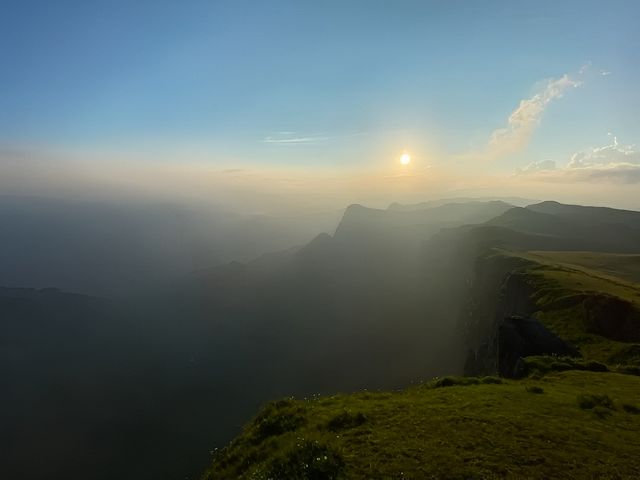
[501,251,640,365]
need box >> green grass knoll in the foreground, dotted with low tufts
[204,371,640,480]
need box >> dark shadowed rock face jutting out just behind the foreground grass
[494,316,579,377]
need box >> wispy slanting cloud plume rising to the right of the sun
[489,71,586,158]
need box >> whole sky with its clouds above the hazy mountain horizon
[0,0,640,212]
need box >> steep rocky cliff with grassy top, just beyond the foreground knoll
[461,251,640,377]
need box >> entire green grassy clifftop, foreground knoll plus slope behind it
[205,251,640,480]
